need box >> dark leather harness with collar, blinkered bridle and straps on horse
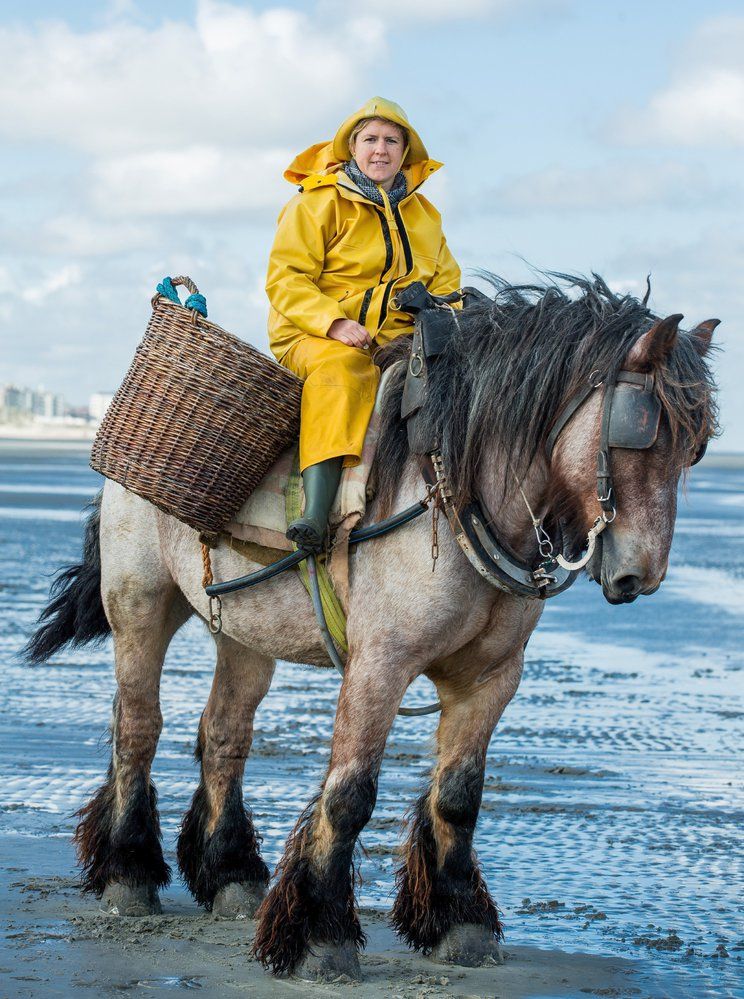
[204,283,705,715]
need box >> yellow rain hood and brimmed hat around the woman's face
[284,97,442,187]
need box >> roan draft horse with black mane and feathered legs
[28,275,717,976]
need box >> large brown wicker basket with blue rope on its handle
[90,277,302,532]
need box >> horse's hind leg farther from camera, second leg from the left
[178,635,274,919]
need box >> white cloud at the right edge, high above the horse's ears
[613,16,744,147]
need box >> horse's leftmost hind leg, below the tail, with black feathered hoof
[75,573,190,916]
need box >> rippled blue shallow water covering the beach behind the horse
[0,448,744,996]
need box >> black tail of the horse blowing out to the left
[21,491,111,665]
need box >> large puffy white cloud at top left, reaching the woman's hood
[0,0,383,155]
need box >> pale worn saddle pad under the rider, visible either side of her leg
[224,365,395,552]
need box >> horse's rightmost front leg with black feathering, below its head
[391,651,522,965]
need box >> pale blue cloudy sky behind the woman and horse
[0,0,744,451]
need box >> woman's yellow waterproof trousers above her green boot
[280,336,380,472]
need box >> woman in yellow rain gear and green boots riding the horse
[266,97,460,552]
